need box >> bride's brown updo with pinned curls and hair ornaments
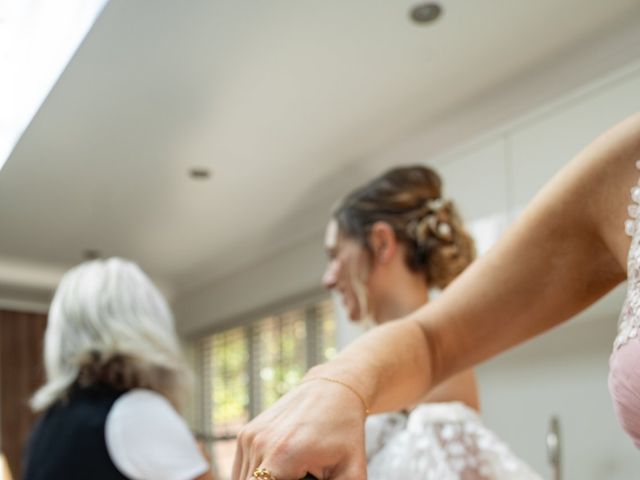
[333,166,475,289]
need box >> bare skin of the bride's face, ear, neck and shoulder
[322,220,480,410]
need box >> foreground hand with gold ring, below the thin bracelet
[232,380,366,480]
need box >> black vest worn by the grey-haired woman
[23,387,128,480]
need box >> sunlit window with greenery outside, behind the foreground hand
[198,300,336,479]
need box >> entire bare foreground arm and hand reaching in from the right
[232,114,640,480]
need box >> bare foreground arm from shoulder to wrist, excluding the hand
[311,115,640,410]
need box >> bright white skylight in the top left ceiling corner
[0,0,108,170]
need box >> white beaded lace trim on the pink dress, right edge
[613,160,640,350]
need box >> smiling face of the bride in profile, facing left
[322,220,367,321]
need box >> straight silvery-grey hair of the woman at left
[31,258,192,411]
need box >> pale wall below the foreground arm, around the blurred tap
[478,308,640,480]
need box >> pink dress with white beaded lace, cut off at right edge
[609,161,640,448]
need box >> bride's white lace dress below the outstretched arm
[365,402,542,480]
